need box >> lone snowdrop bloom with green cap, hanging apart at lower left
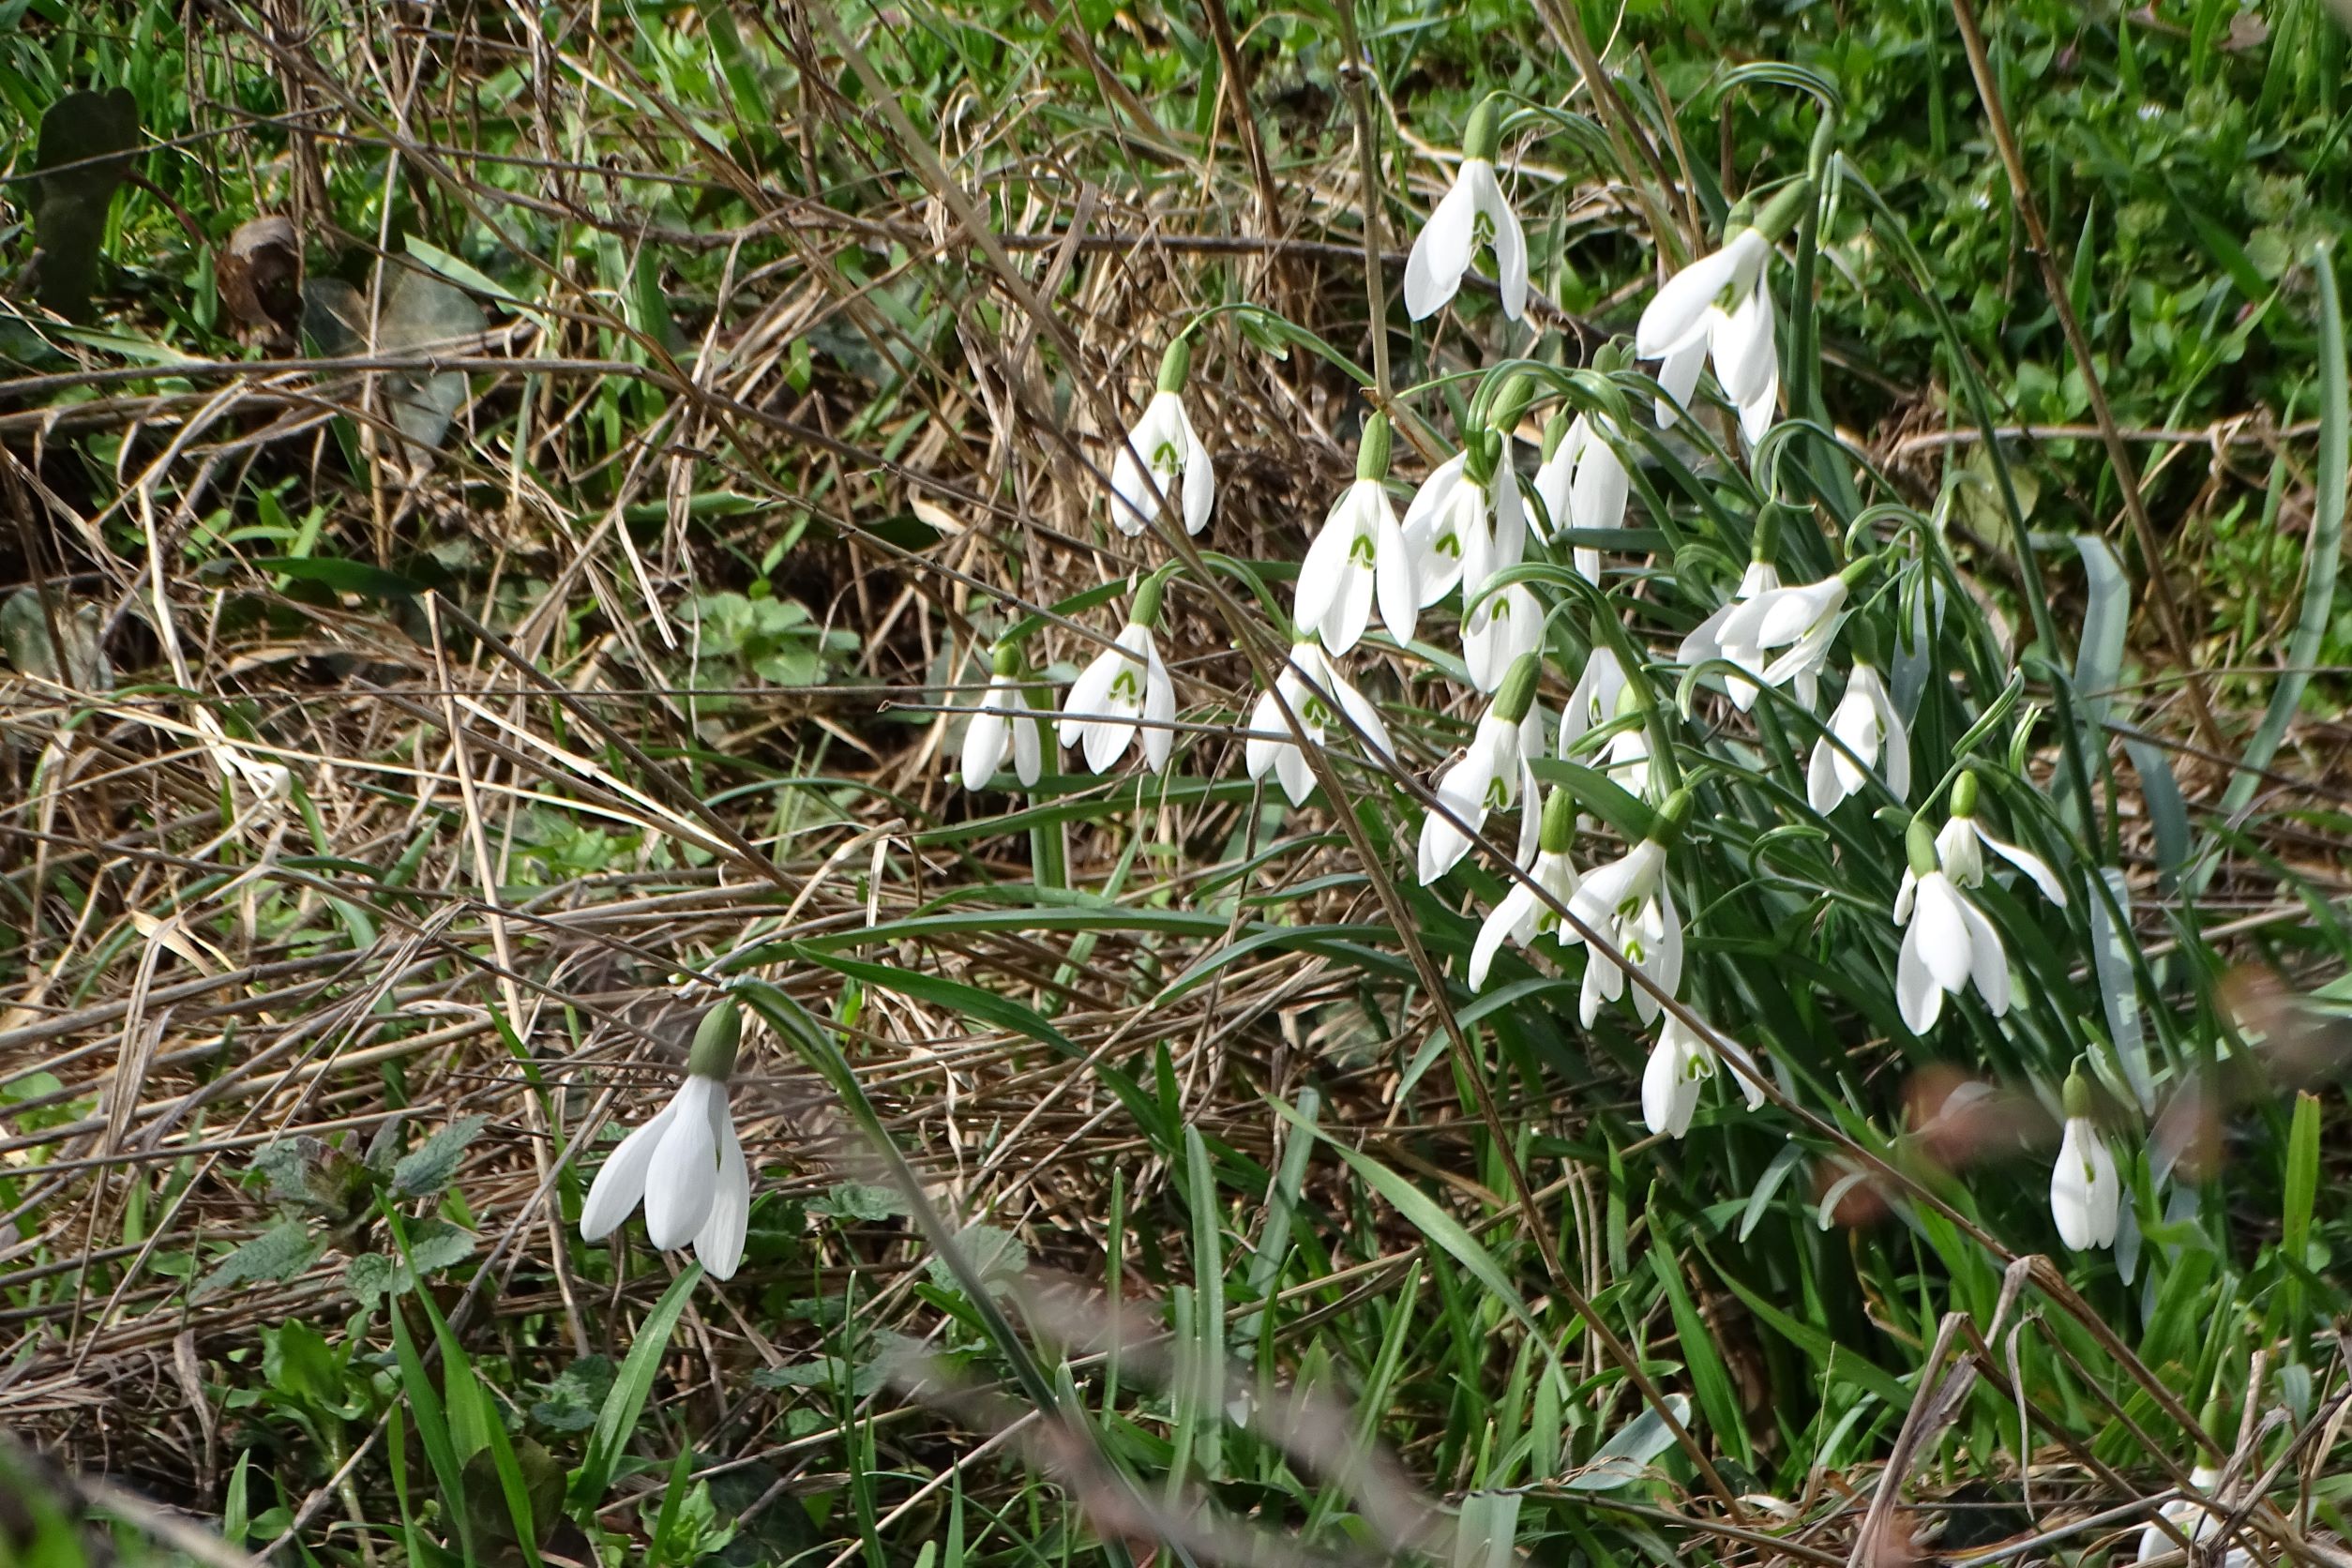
[580,1002,750,1279]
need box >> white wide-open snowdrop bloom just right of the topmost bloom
[1633,228,1781,446]
